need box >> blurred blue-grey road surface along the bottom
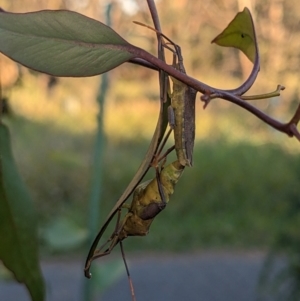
[0,252,276,301]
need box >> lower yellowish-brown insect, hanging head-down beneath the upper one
[85,160,184,278]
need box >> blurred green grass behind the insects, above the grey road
[4,113,300,251]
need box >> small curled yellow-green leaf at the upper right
[212,7,258,63]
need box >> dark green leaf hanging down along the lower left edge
[0,123,45,301]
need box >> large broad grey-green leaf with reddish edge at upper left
[0,10,133,77]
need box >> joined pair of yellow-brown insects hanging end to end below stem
[85,24,196,300]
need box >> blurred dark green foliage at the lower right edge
[259,183,300,301]
